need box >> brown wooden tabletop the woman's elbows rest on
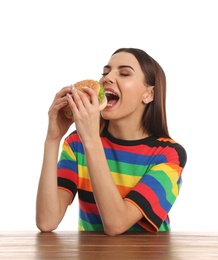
[0,231,218,260]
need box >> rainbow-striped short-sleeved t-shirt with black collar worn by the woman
[58,129,187,232]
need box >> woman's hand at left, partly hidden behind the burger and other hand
[47,86,74,140]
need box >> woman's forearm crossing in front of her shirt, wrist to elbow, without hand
[85,139,134,235]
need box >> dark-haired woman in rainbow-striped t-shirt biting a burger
[36,48,186,236]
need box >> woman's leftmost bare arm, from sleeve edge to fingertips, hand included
[36,87,73,231]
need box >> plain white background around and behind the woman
[0,0,218,231]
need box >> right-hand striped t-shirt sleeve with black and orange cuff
[124,143,186,232]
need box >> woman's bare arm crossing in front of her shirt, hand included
[69,88,142,236]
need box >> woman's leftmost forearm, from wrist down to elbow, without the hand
[36,140,61,230]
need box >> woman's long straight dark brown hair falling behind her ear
[100,48,170,137]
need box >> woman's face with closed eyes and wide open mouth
[100,52,152,123]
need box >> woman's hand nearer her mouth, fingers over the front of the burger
[68,87,100,144]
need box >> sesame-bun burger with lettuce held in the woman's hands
[63,79,107,119]
